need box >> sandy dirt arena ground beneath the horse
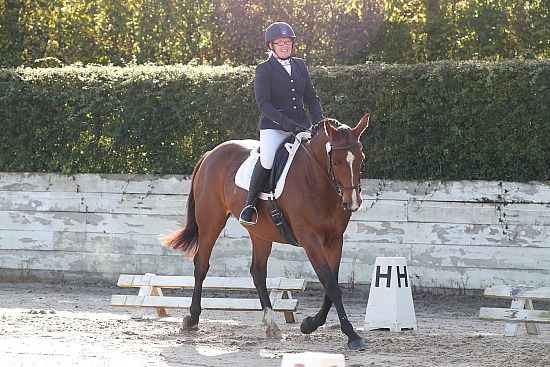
[0,283,550,367]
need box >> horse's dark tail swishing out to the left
[161,153,208,258]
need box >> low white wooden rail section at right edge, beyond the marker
[479,285,550,336]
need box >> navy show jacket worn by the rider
[254,56,323,130]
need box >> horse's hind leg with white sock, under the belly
[250,234,282,340]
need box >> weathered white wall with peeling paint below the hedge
[0,173,550,290]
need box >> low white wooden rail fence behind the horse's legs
[109,274,306,323]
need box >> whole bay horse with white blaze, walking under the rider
[162,114,370,350]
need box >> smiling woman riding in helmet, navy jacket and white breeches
[239,22,323,225]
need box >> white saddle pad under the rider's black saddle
[235,132,311,200]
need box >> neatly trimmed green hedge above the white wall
[0,60,550,182]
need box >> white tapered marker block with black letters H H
[364,257,417,331]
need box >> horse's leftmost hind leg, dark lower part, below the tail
[182,214,228,330]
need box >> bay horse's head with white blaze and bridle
[324,114,370,212]
